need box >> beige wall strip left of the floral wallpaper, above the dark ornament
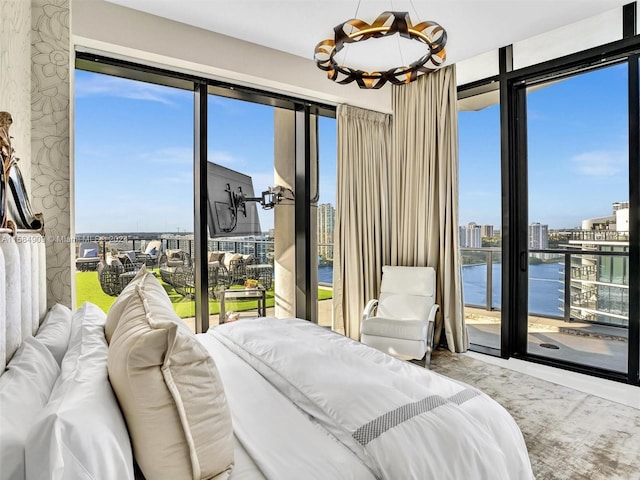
[0,0,31,188]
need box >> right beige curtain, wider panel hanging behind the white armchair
[389,66,468,352]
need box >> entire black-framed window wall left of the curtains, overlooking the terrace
[74,54,335,330]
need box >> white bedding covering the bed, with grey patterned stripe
[199,318,533,480]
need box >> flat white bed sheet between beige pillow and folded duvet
[197,334,375,480]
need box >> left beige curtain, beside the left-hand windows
[333,105,391,340]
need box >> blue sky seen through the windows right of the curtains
[459,65,629,229]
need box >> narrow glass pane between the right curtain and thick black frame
[458,91,502,350]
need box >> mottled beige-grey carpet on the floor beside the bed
[431,349,640,480]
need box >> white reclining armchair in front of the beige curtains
[360,266,439,367]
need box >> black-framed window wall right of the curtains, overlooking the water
[459,3,640,384]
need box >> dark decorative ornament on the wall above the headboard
[0,112,44,231]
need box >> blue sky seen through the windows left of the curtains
[75,70,336,233]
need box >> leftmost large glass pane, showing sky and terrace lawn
[74,69,195,318]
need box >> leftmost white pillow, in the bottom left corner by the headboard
[0,337,60,480]
